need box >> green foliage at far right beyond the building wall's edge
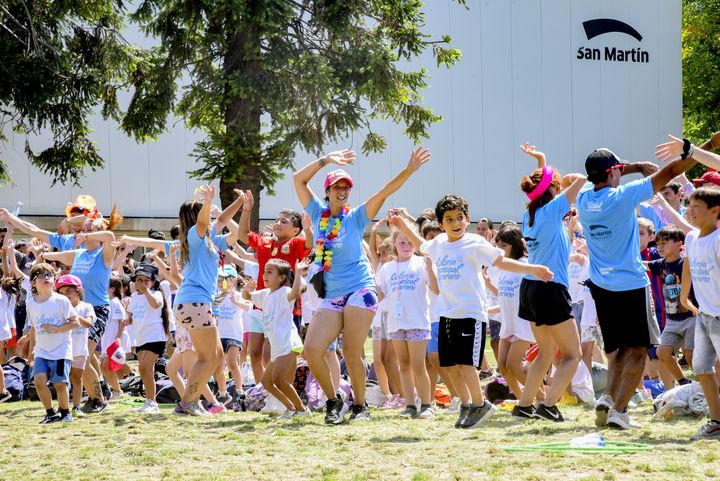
[682,0,720,177]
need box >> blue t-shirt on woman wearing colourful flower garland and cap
[305,196,375,299]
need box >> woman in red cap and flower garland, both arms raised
[293,147,430,424]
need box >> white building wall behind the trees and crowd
[0,0,680,220]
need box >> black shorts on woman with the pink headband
[518,279,572,326]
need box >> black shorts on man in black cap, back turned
[587,281,660,354]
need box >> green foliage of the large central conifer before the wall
[122,0,460,219]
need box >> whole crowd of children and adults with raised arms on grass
[0,132,720,439]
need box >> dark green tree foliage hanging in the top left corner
[0,0,140,183]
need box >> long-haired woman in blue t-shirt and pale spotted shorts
[175,185,245,416]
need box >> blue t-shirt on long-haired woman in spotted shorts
[175,226,228,306]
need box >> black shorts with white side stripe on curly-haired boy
[438,317,485,368]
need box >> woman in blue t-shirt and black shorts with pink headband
[513,144,585,422]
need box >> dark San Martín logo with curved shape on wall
[575,18,650,63]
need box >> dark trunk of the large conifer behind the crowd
[220,7,263,231]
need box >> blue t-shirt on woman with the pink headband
[522,192,570,287]
